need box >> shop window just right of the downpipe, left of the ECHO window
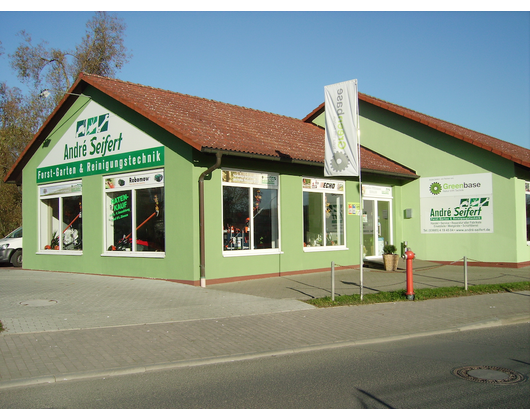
[222,170,280,252]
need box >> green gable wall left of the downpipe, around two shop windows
[23,90,199,281]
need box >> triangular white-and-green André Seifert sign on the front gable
[37,101,164,183]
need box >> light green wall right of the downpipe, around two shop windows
[196,156,359,280]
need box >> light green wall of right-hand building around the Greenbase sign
[360,103,530,263]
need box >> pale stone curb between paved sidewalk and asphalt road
[0,314,530,390]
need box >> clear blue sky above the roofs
[0,11,530,148]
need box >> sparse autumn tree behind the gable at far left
[0,12,130,237]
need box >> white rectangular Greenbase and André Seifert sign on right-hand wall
[420,173,493,233]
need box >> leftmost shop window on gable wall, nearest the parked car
[39,181,83,252]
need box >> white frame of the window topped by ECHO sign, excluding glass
[302,177,348,252]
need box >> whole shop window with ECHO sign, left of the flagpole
[302,178,346,250]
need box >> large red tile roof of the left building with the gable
[4,73,417,183]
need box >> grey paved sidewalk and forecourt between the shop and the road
[0,263,530,388]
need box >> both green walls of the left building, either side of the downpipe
[23,89,366,282]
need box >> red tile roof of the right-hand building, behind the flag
[302,92,530,168]
